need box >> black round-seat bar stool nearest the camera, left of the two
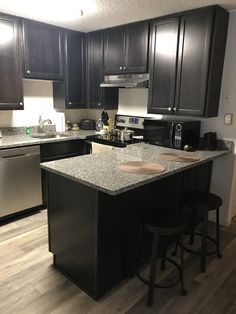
[136,208,187,306]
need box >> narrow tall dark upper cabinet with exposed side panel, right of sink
[53,30,86,109]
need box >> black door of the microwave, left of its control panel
[143,119,175,147]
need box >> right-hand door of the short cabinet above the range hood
[124,22,149,73]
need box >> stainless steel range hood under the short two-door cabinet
[100,73,149,88]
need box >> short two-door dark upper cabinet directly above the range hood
[104,22,149,74]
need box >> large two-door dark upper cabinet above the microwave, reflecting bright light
[148,6,228,117]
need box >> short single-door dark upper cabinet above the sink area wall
[22,20,63,80]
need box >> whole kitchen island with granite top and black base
[41,143,229,299]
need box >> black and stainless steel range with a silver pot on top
[87,114,144,147]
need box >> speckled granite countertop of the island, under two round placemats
[41,143,230,195]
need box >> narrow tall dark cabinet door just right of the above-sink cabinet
[66,31,86,109]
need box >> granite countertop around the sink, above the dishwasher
[0,130,95,149]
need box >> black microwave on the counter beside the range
[143,119,201,149]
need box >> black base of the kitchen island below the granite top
[47,162,212,300]
